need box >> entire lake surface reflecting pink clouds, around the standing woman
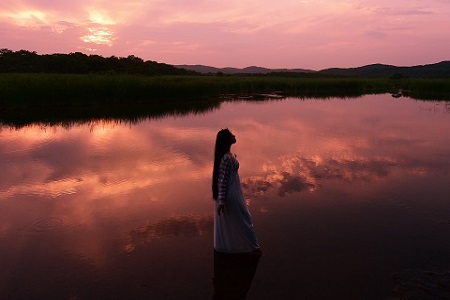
[0,95,450,300]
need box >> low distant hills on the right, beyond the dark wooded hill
[174,61,450,78]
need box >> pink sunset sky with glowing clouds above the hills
[0,0,450,70]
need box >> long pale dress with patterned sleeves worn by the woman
[214,154,259,253]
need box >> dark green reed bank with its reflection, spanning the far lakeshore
[0,74,450,127]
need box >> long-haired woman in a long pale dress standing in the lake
[212,129,261,254]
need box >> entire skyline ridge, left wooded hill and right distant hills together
[0,49,450,78]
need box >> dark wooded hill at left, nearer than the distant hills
[0,49,195,75]
